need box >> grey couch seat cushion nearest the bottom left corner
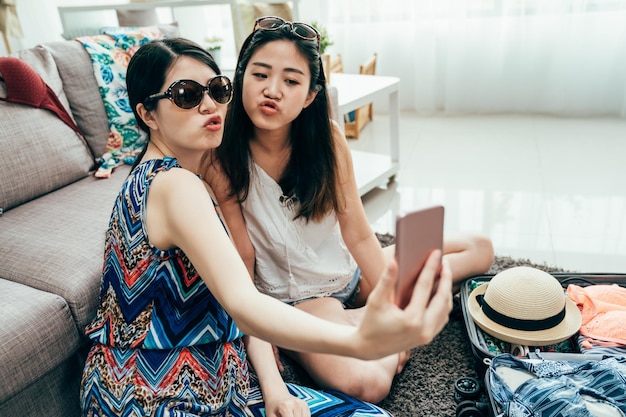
[0,279,81,403]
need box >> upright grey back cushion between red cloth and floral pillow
[44,41,109,156]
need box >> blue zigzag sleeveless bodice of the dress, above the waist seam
[86,158,242,349]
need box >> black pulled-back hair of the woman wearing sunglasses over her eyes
[126,38,221,168]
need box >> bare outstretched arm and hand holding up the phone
[147,169,452,359]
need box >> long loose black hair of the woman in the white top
[213,25,339,221]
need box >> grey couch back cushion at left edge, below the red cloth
[0,87,95,211]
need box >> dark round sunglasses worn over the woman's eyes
[145,75,233,109]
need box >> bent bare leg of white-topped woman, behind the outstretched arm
[284,297,408,403]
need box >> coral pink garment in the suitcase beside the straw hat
[567,284,626,346]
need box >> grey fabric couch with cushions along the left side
[0,41,129,417]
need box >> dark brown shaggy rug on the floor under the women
[282,235,565,417]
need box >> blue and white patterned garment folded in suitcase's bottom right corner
[485,354,626,417]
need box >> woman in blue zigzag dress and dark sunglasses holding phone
[81,35,451,417]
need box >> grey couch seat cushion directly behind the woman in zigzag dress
[0,166,130,334]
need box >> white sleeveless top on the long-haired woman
[242,162,357,302]
